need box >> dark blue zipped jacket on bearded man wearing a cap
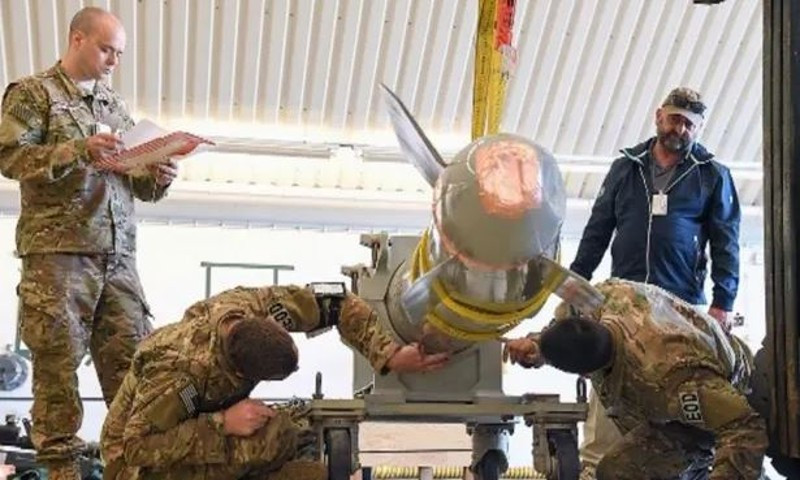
[570,138,741,311]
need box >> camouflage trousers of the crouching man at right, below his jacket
[596,423,714,480]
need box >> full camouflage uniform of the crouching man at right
[556,280,767,480]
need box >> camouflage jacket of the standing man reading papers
[0,64,166,255]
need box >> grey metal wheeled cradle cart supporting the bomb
[340,234,586,478]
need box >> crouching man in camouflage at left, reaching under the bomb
[101,284,447,480]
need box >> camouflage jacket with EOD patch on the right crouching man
[557,280,766,479]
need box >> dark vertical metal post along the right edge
[764,0,800,457]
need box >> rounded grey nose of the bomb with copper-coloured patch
[433,134,566,271]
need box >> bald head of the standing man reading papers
[61,7,126,81]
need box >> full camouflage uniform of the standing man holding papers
[0,64,165,478]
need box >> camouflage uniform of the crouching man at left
[100,287,399,480]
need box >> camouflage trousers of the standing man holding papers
[17,254,152,468]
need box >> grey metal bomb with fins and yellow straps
[383,85,602,353]
